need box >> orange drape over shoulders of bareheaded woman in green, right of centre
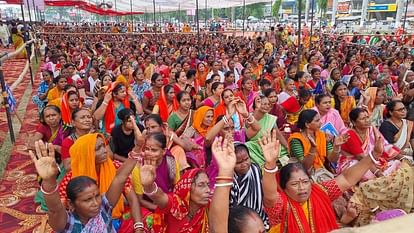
[288,130,327,169]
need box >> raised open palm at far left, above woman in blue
[29,140,59,180]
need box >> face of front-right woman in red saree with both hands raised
[285,169,312,203]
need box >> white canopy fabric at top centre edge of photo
[104,0,275,13]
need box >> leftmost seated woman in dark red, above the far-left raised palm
[29,105,69,157]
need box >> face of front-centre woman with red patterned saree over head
[190,172,211,206]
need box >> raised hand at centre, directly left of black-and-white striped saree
[211,137,237,176]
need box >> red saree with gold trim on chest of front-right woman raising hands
[280,184,338,233]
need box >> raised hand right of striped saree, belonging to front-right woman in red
[259,130,280,165]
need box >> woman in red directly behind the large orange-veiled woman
[61,108,93,171]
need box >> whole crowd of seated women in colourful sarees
[20,20,414,233]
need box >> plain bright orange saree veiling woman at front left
[69,133,124,218]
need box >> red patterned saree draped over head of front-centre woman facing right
[170,168,208,233]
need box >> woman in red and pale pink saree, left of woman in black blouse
[337,108,400,181]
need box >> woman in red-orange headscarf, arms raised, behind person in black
[93,82,142,135]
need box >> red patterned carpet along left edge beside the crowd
[0,53,50,233]
